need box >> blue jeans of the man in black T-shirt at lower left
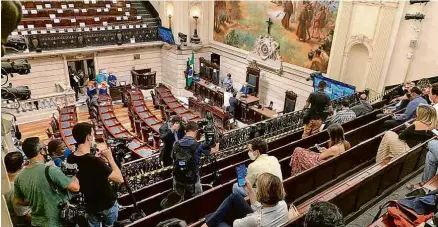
[86,201,119,227]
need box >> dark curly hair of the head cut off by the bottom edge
[304,201,345,227]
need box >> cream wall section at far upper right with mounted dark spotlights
[385,1,438,85]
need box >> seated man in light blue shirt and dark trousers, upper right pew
[383,87,427,129]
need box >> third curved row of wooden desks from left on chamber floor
[125,88,164,149]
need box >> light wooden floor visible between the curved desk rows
[19,101,161,144]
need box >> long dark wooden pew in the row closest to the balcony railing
[119,107,386,205]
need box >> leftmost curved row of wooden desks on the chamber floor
[58,105,78,151]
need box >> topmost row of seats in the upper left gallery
[21,1,131,9]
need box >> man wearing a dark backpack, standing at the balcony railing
[172,121,217,200]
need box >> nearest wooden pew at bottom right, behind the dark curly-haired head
[284,137,430,227]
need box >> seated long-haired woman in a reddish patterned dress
[290,124,351,176]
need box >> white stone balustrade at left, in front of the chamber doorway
[2,90,76,124]
